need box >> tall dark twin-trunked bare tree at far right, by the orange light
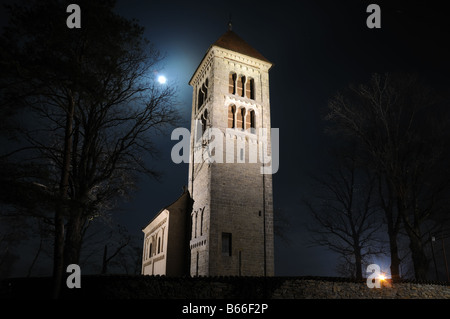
[326,74,450,279]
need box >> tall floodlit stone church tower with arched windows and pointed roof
[188,25,274,276]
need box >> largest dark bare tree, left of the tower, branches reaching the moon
[0,0,178,296]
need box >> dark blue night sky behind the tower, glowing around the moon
[3,0,450,276]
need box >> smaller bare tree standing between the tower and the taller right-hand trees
[305,150,385,279]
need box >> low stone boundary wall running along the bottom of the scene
[0,275,450,299]
